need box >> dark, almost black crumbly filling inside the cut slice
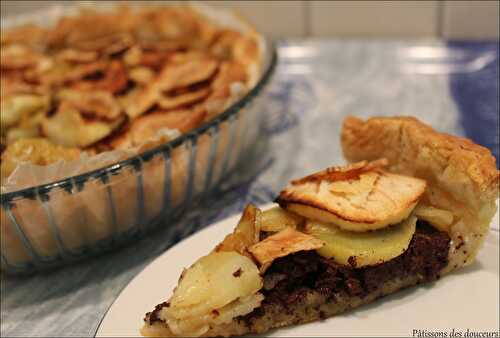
[146,221,450,324]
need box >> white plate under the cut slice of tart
[96,207,500,337]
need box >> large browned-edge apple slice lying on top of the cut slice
[277,161,426,232]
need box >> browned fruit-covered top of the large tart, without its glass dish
[0,5,262,178]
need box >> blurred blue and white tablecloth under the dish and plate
[0,40,499,337]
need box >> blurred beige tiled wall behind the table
[0,0,499,39]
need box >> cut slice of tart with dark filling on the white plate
[141,118,499,337]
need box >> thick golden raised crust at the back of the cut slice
[341,117,500,272]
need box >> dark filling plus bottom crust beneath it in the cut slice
[141,221,450,337]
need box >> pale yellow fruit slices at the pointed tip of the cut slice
[160,251,263,335]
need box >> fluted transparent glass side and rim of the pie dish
[0,2,277,274]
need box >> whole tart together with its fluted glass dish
[0,2,276,274]
